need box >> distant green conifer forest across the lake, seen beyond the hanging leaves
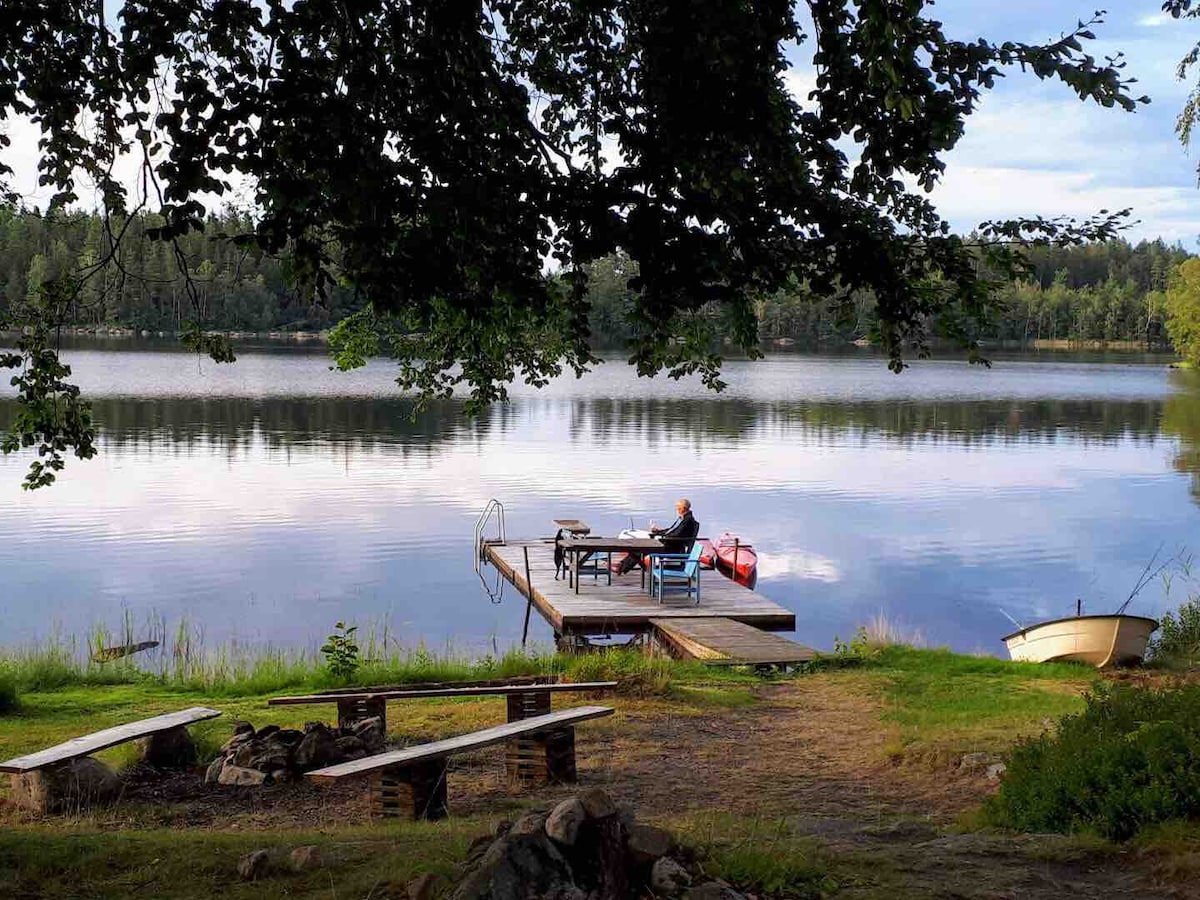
[0,206,1190,347]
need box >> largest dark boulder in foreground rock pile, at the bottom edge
[454,834,586,900]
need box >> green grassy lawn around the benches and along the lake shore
[0,647,1113,898]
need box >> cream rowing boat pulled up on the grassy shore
[1003,616,1158,668]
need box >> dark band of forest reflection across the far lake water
[0,396,1171,451]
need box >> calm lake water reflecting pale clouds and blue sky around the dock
[0,340,1200,654]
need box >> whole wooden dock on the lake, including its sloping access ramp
[482,540,812,665]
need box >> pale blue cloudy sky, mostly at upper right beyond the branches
[6,0,1200,252]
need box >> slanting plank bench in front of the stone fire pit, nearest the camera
[308,707,613,818]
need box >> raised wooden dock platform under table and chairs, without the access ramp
[484,540,796,634]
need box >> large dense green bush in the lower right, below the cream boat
[985,685,1200,840]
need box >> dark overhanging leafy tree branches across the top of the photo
[0,0,1146,485]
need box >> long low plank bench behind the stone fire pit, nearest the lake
[266,682,617,731]
